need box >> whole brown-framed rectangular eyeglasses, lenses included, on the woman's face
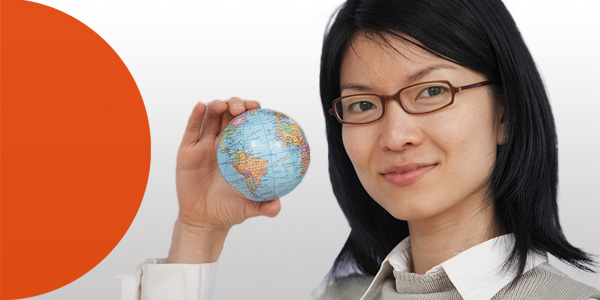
[329,80,492,124]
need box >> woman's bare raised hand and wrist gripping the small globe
[167,98,281,263]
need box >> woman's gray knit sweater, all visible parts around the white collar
[319,263,600,300]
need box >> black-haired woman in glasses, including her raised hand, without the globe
[124,0,600,299]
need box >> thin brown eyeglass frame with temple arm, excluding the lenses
[329,80,492,125]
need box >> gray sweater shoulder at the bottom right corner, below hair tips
[492,263,600,300]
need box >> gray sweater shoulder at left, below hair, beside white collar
[313,273,373,300]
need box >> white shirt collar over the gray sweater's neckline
[361,234,548,300]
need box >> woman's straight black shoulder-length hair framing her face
[320,0,595,282]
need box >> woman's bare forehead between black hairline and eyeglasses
[340,32,468,89]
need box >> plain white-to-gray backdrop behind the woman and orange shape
[24,0,600,299]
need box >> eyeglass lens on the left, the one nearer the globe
[335,95,383,124]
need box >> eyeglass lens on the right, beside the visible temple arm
[400,82,452,113]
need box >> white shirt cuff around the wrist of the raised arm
[117,258,217,300]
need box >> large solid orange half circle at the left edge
[0,0,150,299]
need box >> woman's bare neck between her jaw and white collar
[408,195,501,274]
